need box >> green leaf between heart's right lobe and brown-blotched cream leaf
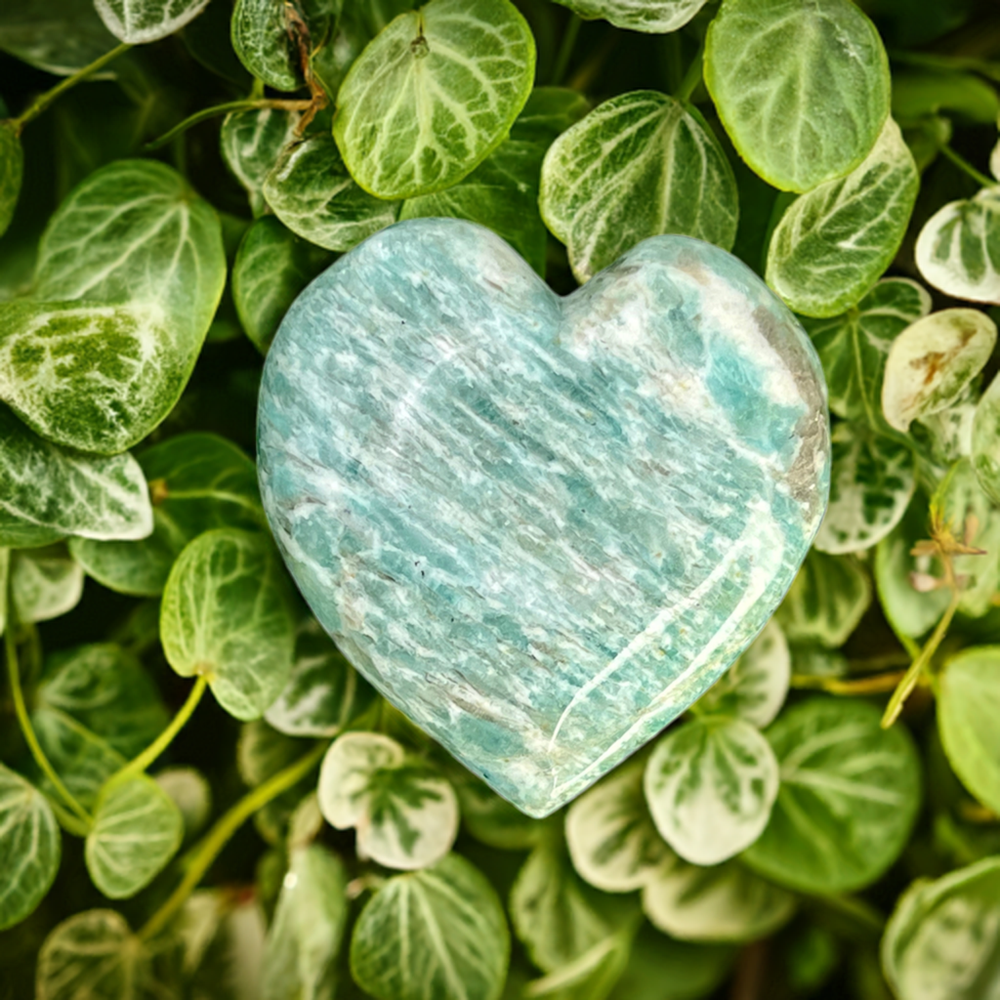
[803,278,931,432]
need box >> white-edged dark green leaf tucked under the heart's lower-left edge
[264,618,377,738]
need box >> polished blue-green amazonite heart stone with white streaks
[258,219,830,816]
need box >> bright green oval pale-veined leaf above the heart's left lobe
[334,0,535,201]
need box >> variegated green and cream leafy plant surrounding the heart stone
[0,0,1000,1000]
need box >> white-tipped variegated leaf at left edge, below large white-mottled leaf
[0,405,153,547]
